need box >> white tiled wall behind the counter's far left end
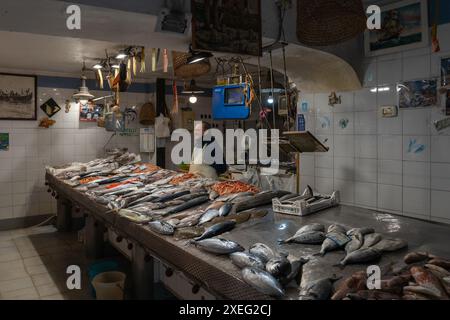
[0,88,153,220]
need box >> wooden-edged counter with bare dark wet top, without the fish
[46,173,450,300]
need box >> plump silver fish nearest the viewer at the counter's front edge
[242,267,285,297]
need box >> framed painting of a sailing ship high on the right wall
[364,0,428,57]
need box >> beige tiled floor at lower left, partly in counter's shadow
[0,226,92,300]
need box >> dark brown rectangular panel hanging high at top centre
[191,0,262,56]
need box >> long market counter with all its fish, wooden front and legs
[46,153,450,300]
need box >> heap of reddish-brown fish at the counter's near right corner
[331,252,450,300]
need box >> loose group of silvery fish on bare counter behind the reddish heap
[280,223,408,267]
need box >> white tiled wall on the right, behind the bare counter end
[302,24,450,224]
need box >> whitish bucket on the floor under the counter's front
[92,271,126,300]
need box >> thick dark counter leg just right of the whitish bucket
[132,245,154,300]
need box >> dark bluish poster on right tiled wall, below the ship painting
[397,80,437,108]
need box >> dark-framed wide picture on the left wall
[0,73,37,120]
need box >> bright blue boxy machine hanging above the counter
[212,83,250,120]
